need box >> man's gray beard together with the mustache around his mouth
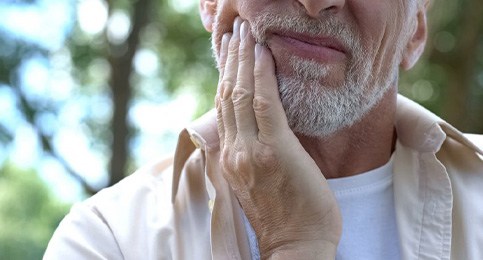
[213,13,400,138]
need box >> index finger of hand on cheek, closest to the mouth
[253,44,289,141]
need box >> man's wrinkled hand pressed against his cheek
[215,17,342,259]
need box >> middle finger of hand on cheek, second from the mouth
[232,21,258,138]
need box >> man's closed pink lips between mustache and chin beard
[268,32,347,63]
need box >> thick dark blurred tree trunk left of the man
[107,0,152,186]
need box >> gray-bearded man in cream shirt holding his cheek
[45,0,483,259]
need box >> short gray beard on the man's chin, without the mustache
[277,57,397,138]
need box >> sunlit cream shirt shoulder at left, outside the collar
[45,160,176,259]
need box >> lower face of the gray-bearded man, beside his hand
[213,0,415,137]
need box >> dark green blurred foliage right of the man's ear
[399,0,483,133]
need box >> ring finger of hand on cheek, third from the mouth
[220,17,241,144]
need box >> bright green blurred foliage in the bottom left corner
[0,164,69,260]
